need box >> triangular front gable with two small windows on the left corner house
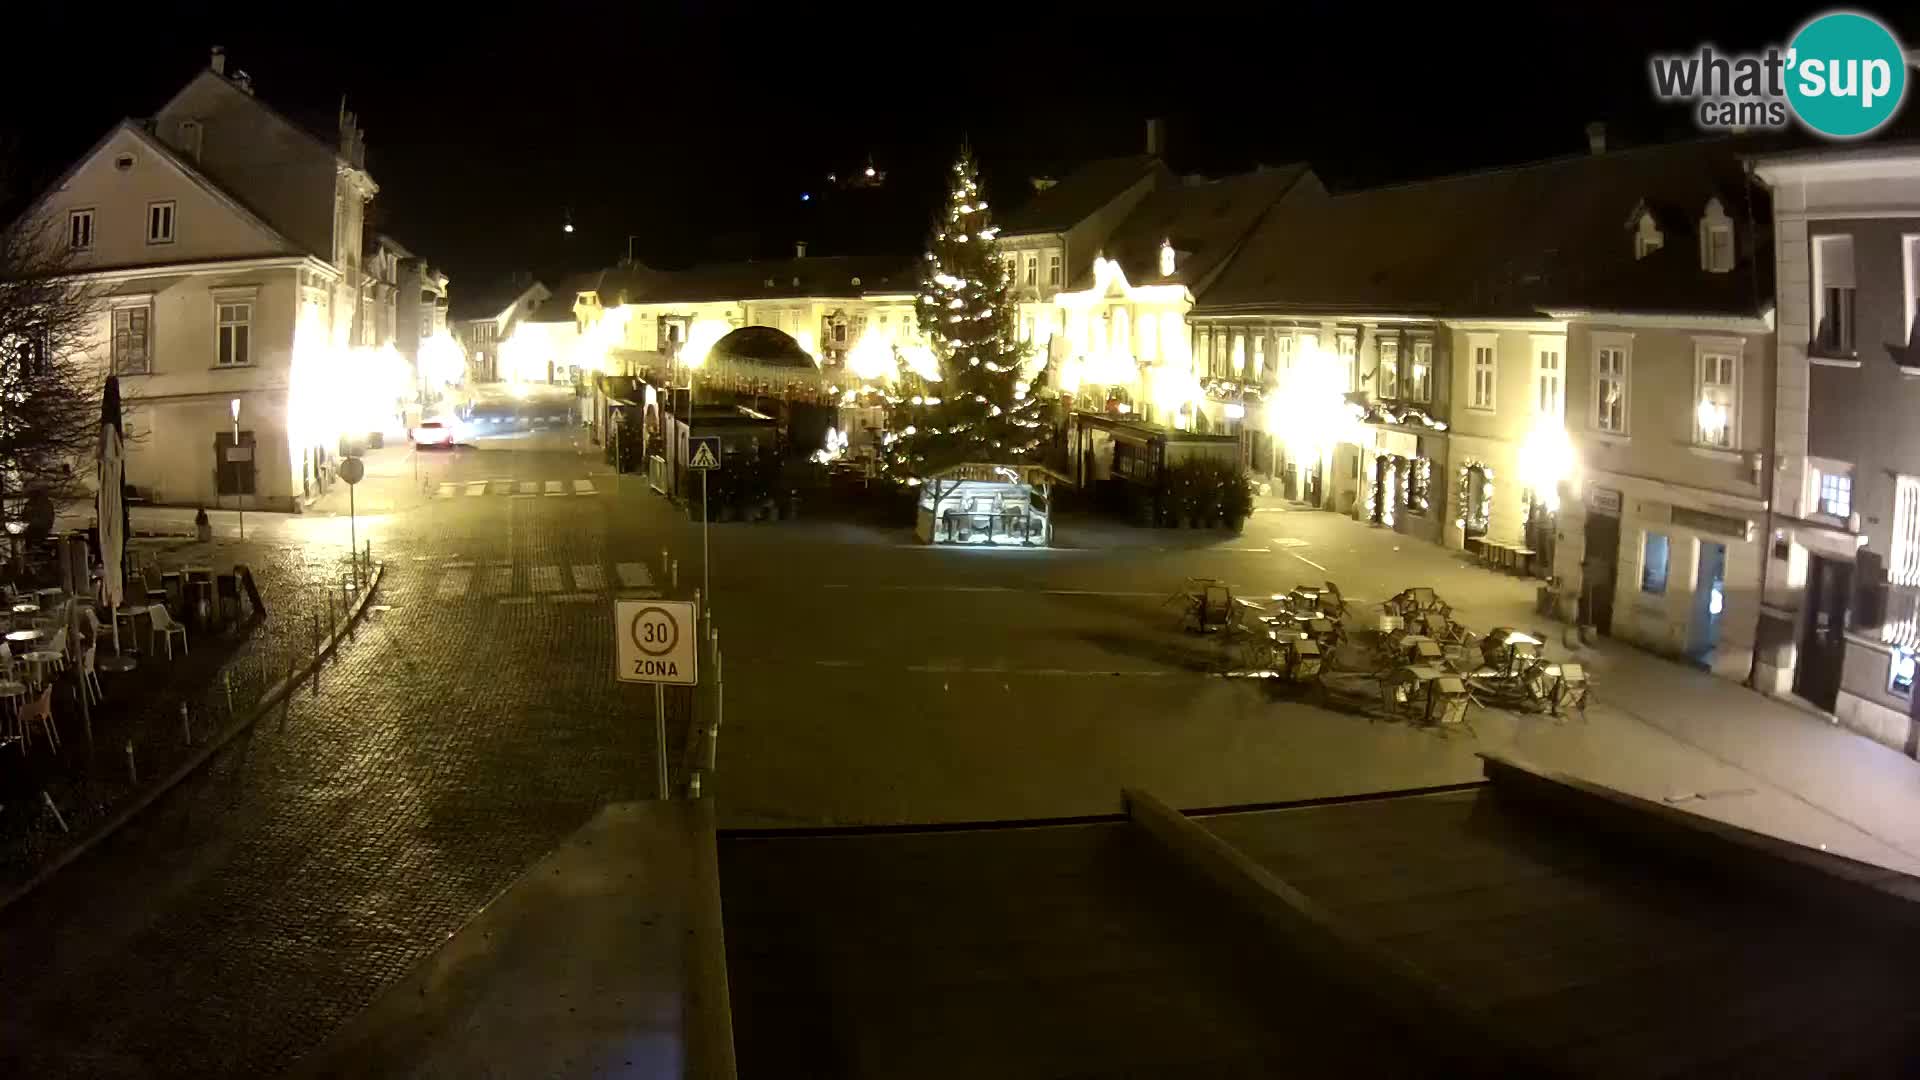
[35,123,298,271]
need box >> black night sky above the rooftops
[0,0,1920,294]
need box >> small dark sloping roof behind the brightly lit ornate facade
[1075,165,1308,292]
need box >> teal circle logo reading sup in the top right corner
[1786,12,1907,138]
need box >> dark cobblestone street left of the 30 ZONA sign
[0,430,678,1076]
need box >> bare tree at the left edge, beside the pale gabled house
[0,204,104,532]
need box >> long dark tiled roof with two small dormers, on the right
[1198,138,1772,317]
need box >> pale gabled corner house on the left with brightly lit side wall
[16,50,392,511]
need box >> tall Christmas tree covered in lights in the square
[887,150,1046,479]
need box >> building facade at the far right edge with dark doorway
[1755,146,1920,755]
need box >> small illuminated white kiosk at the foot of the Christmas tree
[914,461,1054,548]
